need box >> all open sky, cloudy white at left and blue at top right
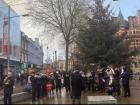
[5,0,140,62]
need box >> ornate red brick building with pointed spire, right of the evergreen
[117,10,140,69]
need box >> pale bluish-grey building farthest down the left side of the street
[28,38,44,68]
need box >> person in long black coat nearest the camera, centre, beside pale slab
[71,71,82,104]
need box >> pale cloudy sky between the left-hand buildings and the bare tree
[5,0,64,61]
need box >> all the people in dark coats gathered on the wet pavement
[3,65,131,104]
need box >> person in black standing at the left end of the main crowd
[30,72,37,102]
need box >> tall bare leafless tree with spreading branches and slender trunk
[30,0,84,71]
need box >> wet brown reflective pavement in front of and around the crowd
[14,81,140,104]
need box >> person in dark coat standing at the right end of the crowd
[121,67,130,97]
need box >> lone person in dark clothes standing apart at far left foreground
[4,71,14,104]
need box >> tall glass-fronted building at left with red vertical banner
[0,0,21,74]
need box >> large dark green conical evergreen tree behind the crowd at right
[77,0,135,66]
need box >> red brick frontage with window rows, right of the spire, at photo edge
[127,9,140,70]
